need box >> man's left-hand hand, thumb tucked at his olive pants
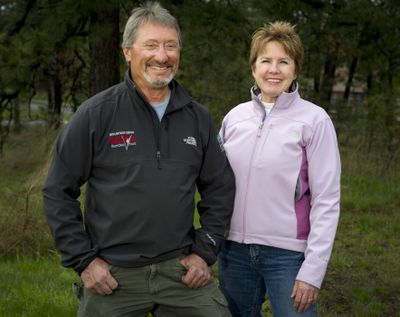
[81,258,118,295]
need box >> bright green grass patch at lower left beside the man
[0,256,78,317]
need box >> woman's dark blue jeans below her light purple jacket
[218,241,316,317]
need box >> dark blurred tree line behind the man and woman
[0,0,400,169]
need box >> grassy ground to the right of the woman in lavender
[319,149,400,317]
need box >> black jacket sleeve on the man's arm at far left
[43,106,98,274]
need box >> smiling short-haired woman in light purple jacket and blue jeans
[218,22,340,317]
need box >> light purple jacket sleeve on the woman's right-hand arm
[297,118,341,288]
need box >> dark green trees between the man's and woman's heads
[168,0,252,125]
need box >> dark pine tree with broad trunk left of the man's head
[0,0,119,128]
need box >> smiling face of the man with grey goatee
[123,23,180,93]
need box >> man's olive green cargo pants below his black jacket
[78,258,231,317]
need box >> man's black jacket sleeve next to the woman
[192,114,235,265]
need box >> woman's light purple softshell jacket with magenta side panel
[220,87,340,288]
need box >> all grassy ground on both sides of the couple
[0,124,400,317]
